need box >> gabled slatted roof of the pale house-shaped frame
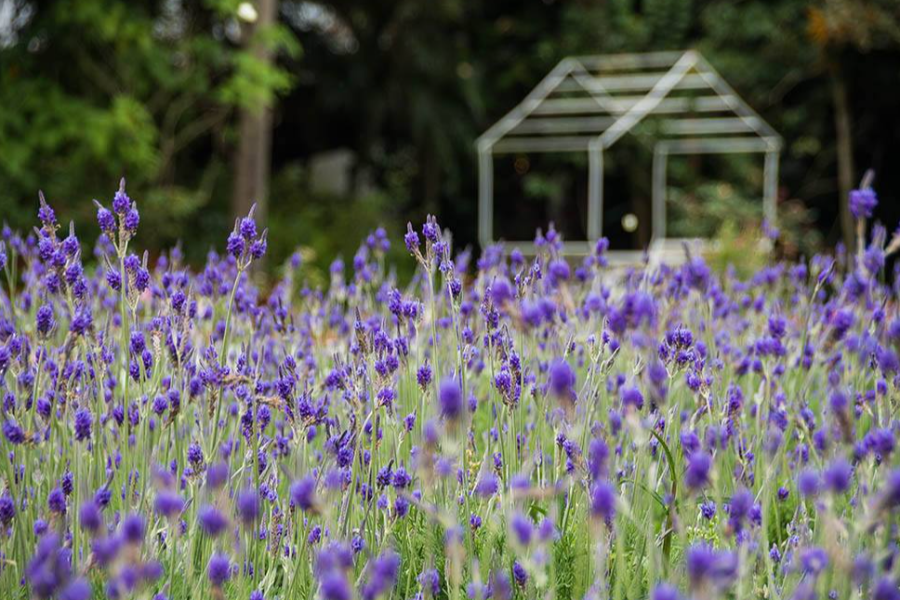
[478,50,781,154]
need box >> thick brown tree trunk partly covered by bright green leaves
[231,0,278,226]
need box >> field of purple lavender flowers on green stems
[0,182,900,600]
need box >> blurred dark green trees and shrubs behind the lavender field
[0,0,900,276]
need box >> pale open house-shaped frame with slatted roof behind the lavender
[477,50,782,254]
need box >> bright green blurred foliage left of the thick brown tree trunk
[0,0,298,252]
